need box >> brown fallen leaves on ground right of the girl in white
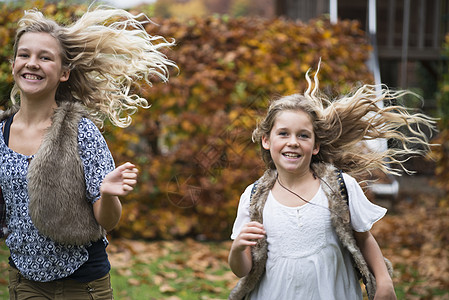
[372,184,449,299]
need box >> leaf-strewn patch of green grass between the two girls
[107,239,237,299]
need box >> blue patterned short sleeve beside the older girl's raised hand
[78,118,115,203]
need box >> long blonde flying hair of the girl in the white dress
[253,66,435,175]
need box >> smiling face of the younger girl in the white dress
[262,110,320,174]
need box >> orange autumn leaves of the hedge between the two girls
[131,17,370,238]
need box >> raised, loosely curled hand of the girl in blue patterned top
[100,162,138,196]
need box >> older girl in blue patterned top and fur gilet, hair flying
[0,8,174,299]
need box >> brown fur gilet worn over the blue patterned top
[0,102,106,245]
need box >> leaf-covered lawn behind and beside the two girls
[0,175,449,300]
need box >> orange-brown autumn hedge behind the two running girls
[0,1,371,239]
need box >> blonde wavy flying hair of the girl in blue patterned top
[10,6,176,127]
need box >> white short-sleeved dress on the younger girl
[231,174,386,300]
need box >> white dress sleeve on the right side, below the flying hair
[343,174,387,232]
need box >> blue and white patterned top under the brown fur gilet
[0,118,115,282]
